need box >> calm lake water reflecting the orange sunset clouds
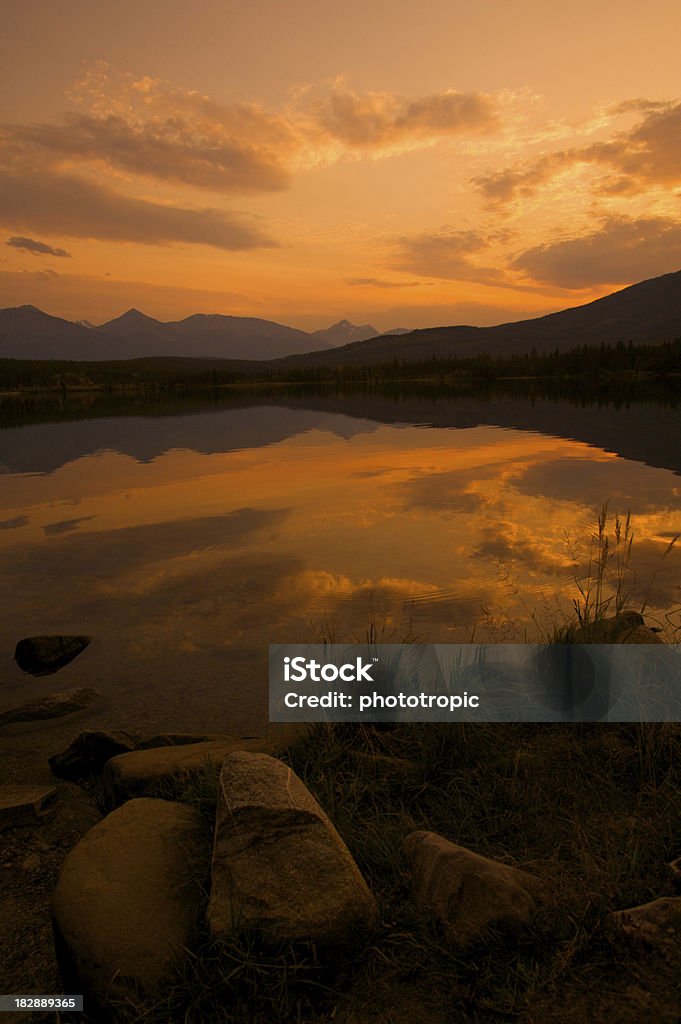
[0,395,681,734]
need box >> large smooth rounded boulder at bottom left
[52,799,209,1006]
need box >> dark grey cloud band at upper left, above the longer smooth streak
[4,114,290,193]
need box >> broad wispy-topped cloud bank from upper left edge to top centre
[1,61,498,193]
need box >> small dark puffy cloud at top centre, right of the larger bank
[315,90,497,148]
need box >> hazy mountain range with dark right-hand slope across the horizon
[0,270,681,369]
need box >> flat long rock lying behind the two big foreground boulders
[102,736,280,807]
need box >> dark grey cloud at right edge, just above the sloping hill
[512,217,681,289]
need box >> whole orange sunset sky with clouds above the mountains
[0,0,681,330]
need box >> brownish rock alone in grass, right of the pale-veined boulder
[403,831,539,949]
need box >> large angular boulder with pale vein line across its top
[208,751,376,946]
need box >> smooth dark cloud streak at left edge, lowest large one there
[0,170,275,250]
